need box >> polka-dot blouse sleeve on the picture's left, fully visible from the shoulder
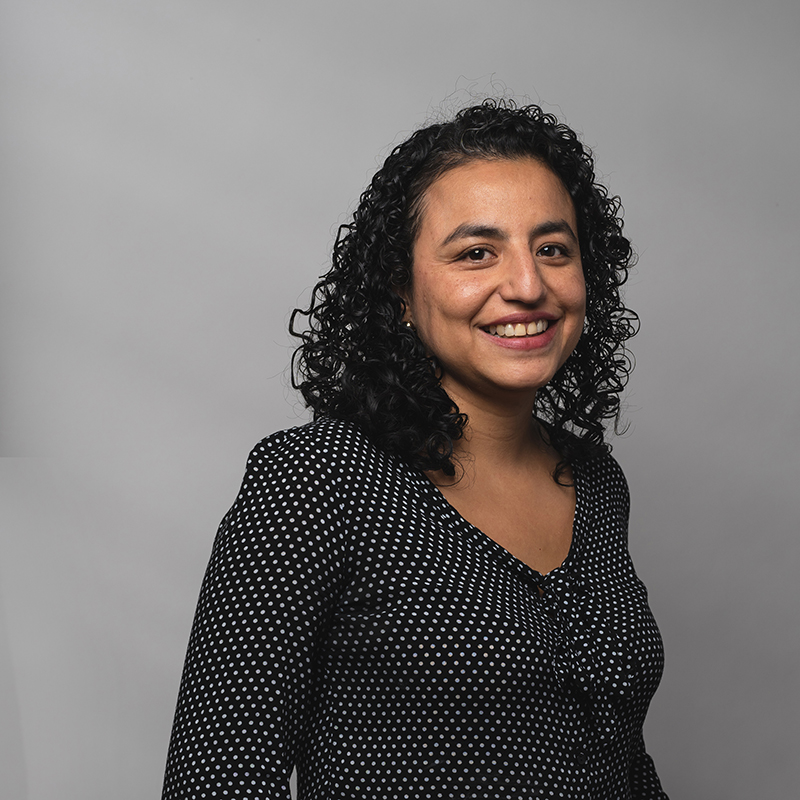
[162,433,345,800]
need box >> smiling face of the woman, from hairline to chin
[404,158,586,410]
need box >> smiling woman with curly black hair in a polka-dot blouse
[164,101,665,800]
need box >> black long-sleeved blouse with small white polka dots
[163,420,666,800]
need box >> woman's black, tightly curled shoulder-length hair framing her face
[289,100,638,481]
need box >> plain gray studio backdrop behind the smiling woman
[0,0,800,800]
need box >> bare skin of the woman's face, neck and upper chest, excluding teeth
[403,158,586,573]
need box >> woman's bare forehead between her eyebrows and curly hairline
[419,158,577,236]
